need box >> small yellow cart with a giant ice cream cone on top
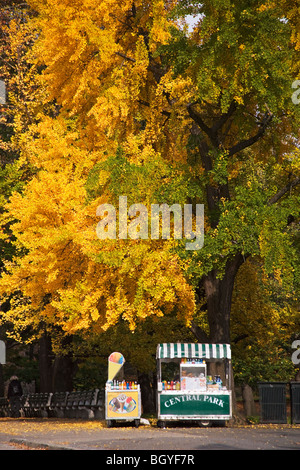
[105,352,141,427]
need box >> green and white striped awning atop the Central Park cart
[156,343,231,359]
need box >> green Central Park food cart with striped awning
[156,343,232,427]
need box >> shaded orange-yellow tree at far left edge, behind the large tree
[0,1,49,330]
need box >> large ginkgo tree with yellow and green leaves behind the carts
[1,0,300,370]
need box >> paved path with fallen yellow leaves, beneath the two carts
[0,418,300,452]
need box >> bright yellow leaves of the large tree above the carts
[0,0,299,358]
